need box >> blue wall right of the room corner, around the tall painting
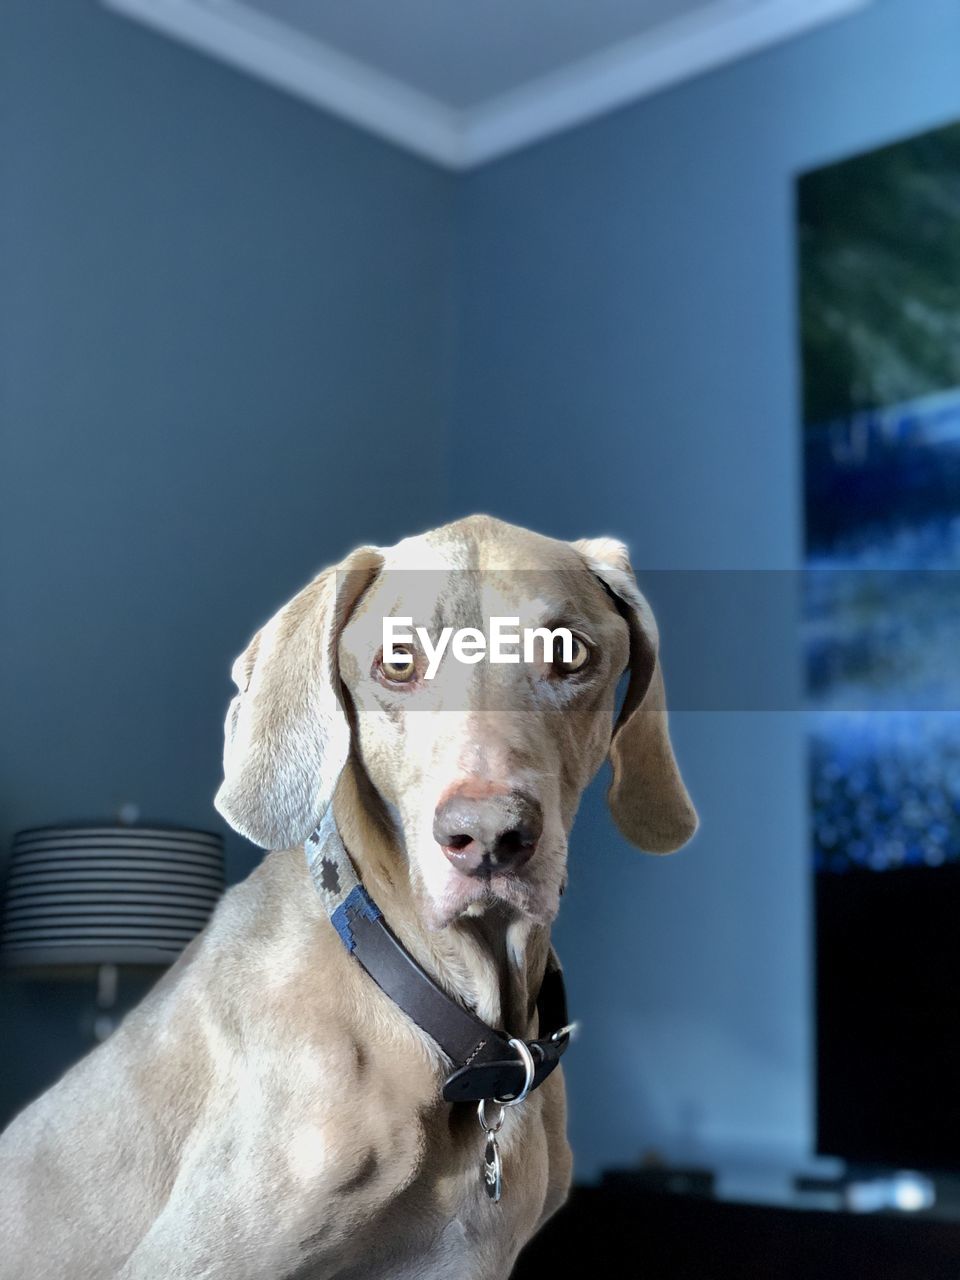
[452,0,960,1176]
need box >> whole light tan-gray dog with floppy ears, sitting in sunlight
[0,516,698,1280]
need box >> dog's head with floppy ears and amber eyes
[216,516,696,927]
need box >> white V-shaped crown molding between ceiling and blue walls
[101,0,873,169]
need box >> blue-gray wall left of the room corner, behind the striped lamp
[0,0,452,1116]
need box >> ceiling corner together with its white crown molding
[102,0,872,169]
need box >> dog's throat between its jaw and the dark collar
[334,763,550,1037]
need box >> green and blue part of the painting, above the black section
[797,124,960,872]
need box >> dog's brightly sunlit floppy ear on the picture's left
[214,547,383,849]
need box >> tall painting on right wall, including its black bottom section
[797,124,960,1167]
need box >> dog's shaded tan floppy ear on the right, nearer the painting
[573,538,698,854]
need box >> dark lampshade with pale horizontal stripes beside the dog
[0,827,224,969]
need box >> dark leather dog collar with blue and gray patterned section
[305,806,571,1102]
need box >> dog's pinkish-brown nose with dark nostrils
[434,791,543,876]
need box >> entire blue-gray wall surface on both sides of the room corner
[0,0,960,1176]
